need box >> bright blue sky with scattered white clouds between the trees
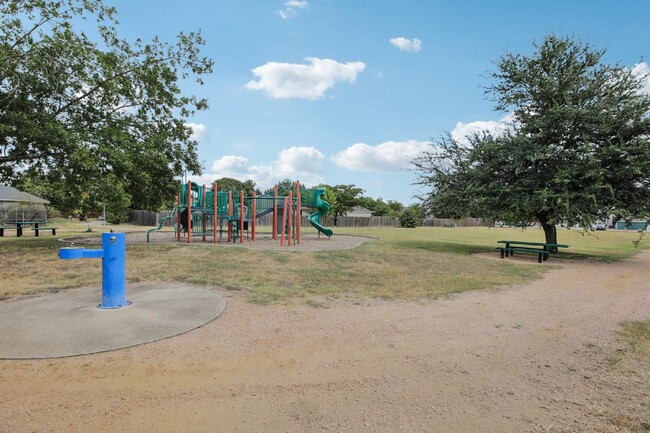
[105,0,650,204]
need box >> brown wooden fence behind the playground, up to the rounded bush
[129,210,399,227]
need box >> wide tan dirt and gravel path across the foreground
[0,251,650,433]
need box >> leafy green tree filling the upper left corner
[0,0,212,216]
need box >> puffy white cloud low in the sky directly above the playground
[202,146,325,189]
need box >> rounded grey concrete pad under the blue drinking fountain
[0,284,225,359]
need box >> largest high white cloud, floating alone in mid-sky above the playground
[246,57,366,100]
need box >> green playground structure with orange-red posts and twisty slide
[147,181,333,246]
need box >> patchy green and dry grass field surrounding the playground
[0,220,650,306]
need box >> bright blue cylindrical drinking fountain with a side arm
[59,233,129,309]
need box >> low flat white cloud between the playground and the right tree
[332,140,429,172]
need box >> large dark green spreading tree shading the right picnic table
[414,35,650,243]
